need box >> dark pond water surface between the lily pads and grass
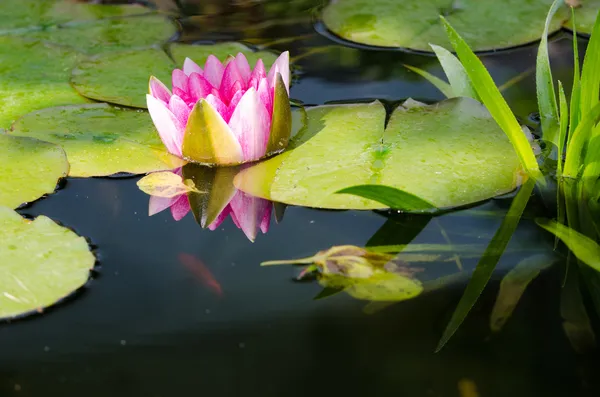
[0,0,600,397]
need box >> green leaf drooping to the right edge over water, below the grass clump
[535,219,600,272]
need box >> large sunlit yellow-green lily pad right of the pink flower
[235,98,521,210]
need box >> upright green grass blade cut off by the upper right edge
[580,8,600,122]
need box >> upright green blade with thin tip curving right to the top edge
[535,0,564,147]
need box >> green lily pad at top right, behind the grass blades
[322,0,564,52]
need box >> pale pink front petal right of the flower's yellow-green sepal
[229,88,270,161]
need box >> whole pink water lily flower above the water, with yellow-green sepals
[146,51,292,165]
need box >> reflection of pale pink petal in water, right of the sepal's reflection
[229,190,269,241]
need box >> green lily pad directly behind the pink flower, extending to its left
[71,43,277,109]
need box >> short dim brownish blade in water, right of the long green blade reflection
[490,253,556,332]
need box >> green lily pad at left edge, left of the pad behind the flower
[0,36,88,128]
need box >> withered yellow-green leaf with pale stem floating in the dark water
[262,245,423,301]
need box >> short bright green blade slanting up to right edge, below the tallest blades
[563,103,600,178]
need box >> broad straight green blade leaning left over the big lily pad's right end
[440,17,542,179]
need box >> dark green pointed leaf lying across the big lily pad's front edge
[336,185,437,212]
